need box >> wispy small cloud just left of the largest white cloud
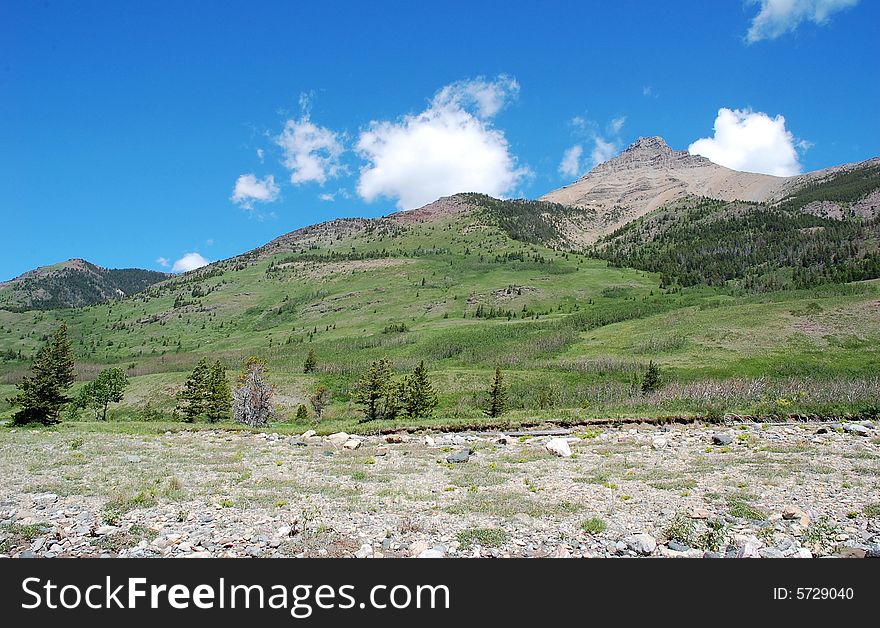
[275,114,345,185]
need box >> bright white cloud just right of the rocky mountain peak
[688,108,801,177]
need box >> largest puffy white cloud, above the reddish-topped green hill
[357,76,530,209]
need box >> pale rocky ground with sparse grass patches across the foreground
[0,423,880,558]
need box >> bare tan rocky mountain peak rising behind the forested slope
[541,137,880,242]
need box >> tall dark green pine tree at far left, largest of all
[7,323,74,425]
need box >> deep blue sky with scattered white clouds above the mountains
[0,0,880,279]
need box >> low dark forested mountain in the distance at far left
[0,259,171,310]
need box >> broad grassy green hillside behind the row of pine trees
[0,189,880,431]
